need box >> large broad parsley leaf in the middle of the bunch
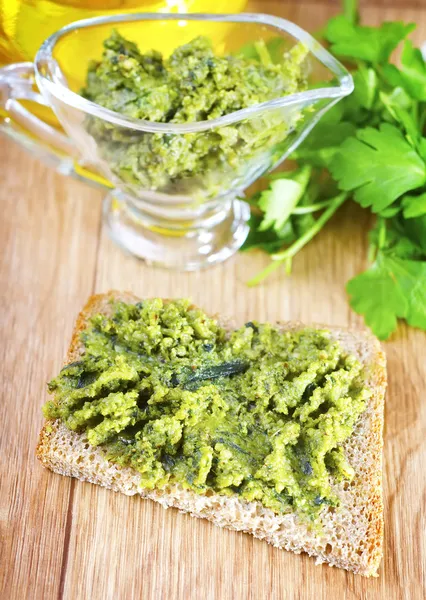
[330,123,426,213]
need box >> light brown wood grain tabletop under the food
[0,0,426,600]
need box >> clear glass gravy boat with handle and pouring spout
[0,13,353,270]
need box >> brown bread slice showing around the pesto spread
[37,292,386,577]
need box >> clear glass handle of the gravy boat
[0,62,112,188]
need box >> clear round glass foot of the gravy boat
[103,192,250,271]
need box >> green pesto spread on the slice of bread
[44,299,369,519]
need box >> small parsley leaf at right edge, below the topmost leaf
[383,40,426,101]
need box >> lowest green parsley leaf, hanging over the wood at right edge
[346,252,426,340]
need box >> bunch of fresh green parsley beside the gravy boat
[243,0,426,339]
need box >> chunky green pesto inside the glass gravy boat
[82,31,307,196]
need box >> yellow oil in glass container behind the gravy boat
[0,0,247,65]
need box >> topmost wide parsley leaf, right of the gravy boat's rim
[325,15,415,63]
